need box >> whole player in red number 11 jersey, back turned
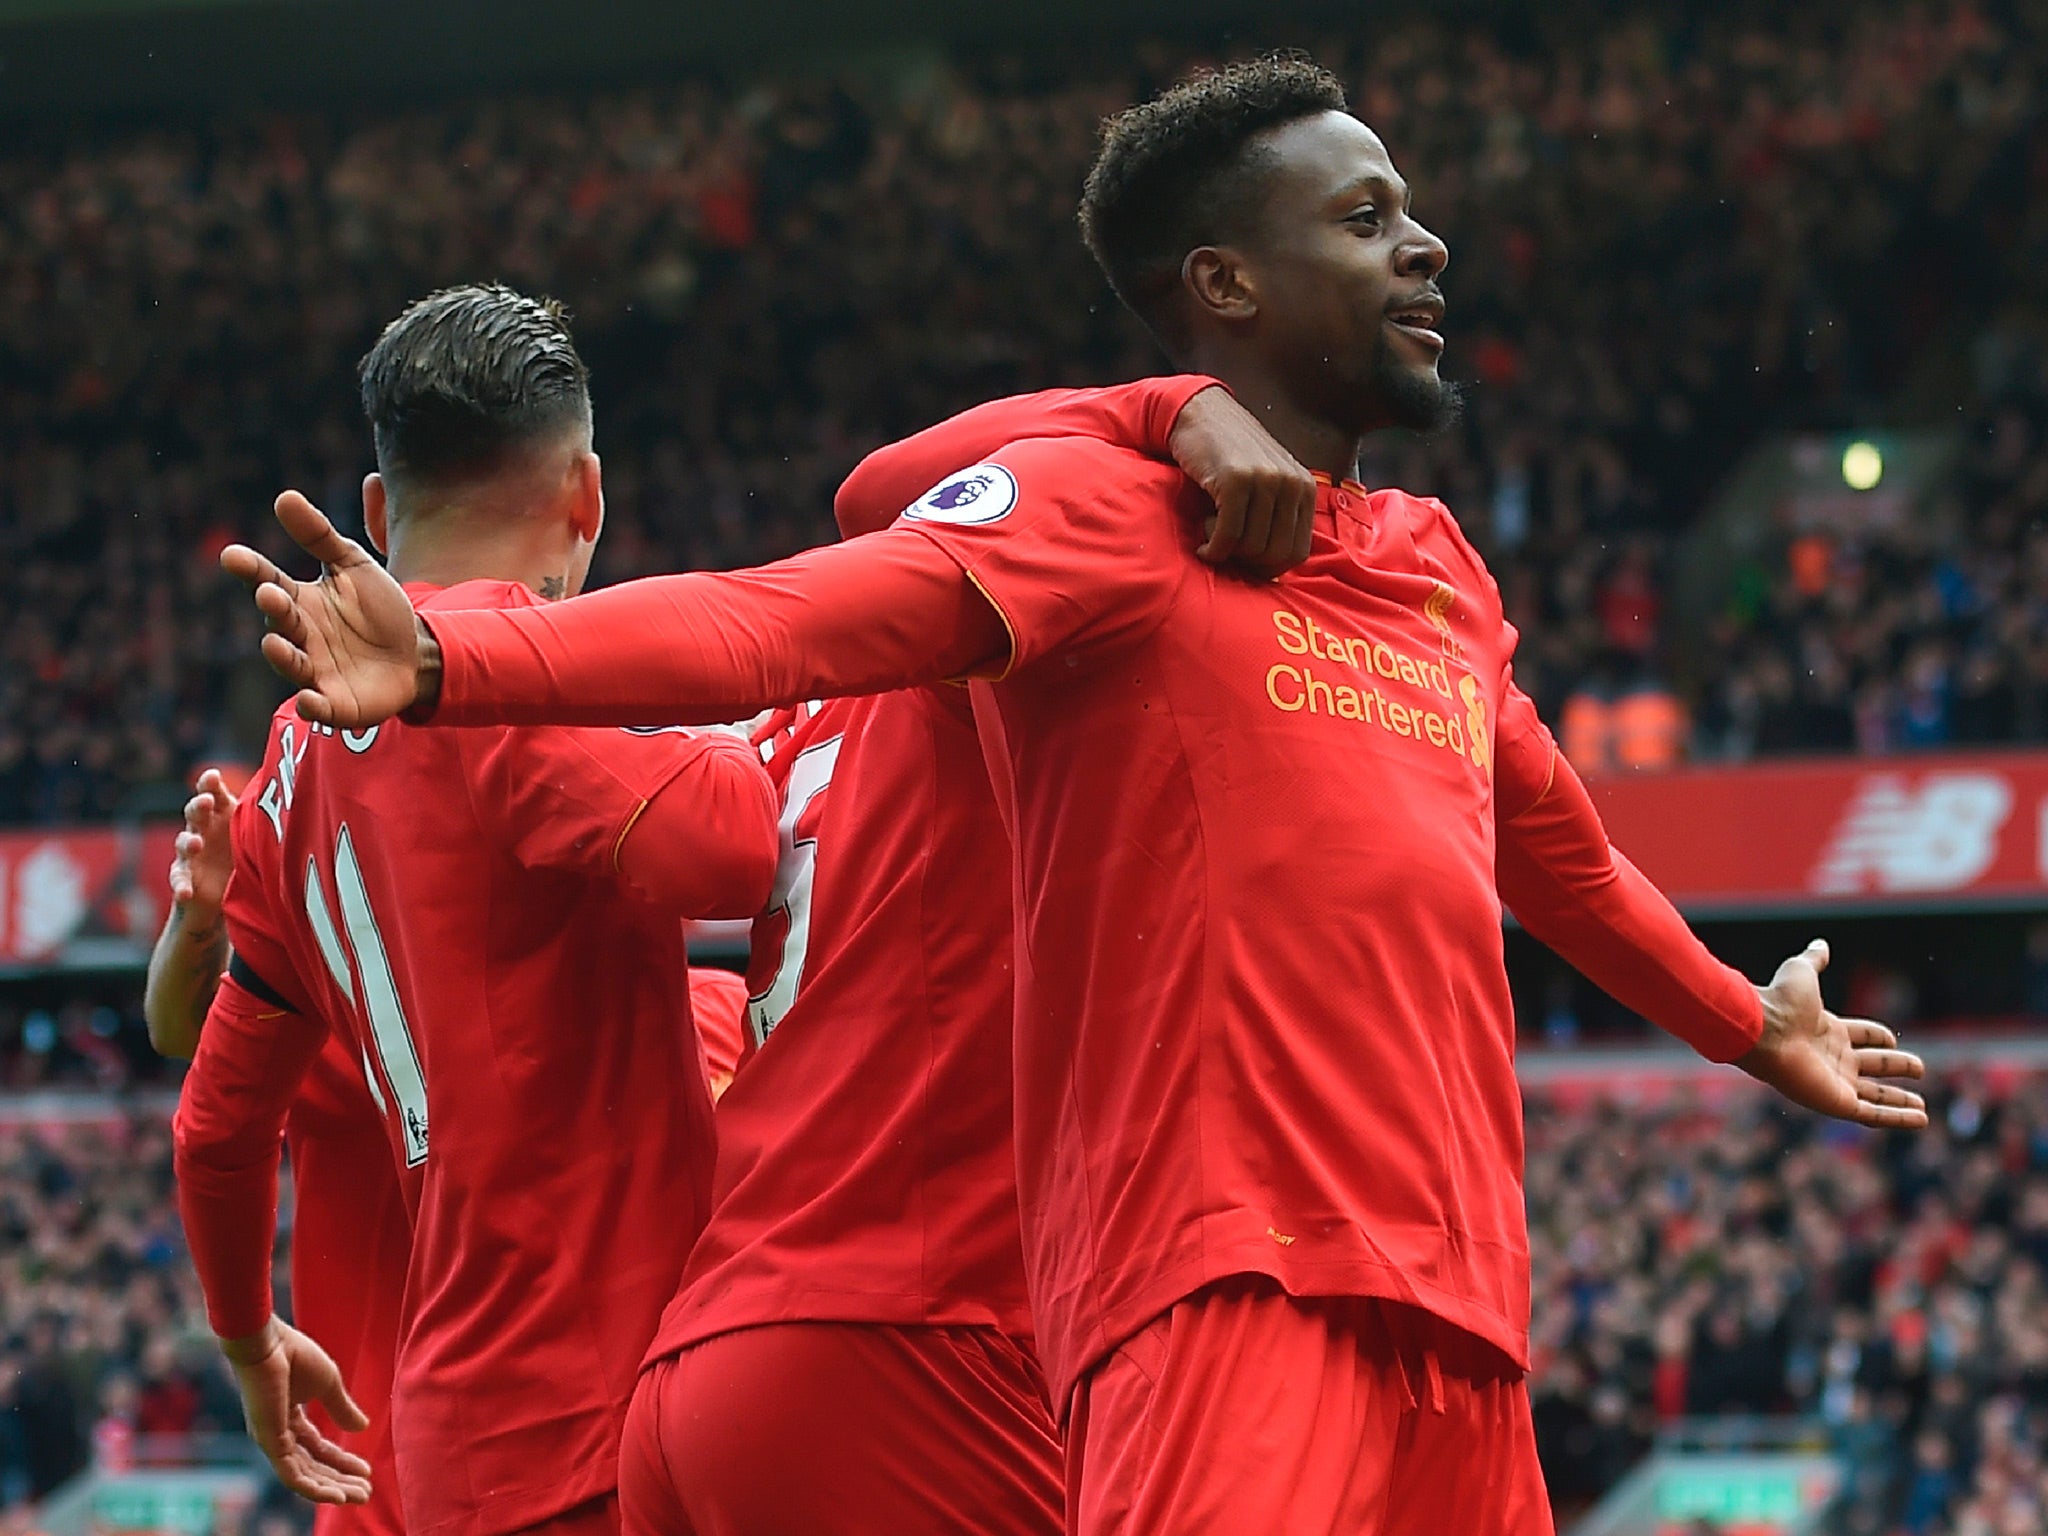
[176,289,774,1536]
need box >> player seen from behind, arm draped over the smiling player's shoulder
[621,379,1313,1536]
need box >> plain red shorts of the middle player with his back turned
[618,1323,1063,1536]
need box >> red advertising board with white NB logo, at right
[1591,752,2048,911]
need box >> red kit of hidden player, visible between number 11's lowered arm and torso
[285,1032,412,1536]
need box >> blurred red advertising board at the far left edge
[0,821,178,967]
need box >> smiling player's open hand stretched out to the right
[1735,938,1927,1130]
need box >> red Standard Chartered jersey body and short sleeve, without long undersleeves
[901,440,1528,1405]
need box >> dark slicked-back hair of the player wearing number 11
[358,283,590,485]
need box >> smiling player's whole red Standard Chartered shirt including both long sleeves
[419,423,1761,1403]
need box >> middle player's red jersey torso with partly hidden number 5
[651,688,1030,1358]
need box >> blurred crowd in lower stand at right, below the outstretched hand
[1528,1077,2048,1536]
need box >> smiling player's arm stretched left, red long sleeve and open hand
[221,492,1010,729]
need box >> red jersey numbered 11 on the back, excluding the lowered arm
[207,582,733,1536]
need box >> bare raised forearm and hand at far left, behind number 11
[141,768,236,1061]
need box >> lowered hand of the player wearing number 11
[221,1317,371,1503]
